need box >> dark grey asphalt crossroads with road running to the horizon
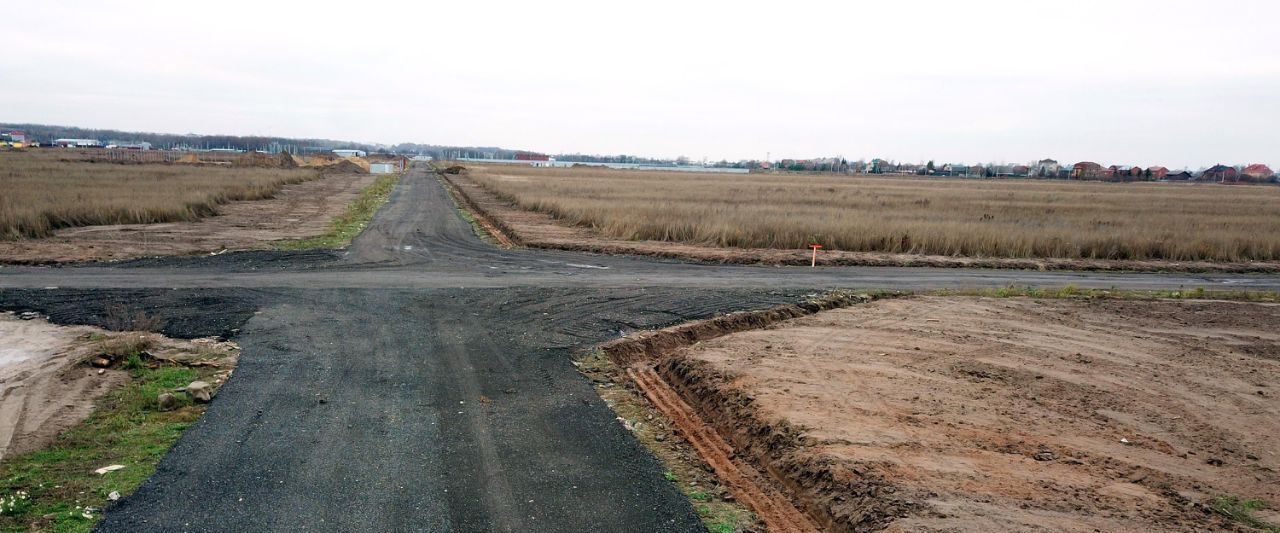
[0,164,1280,532]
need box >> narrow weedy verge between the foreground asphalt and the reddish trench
[577,350,764,533]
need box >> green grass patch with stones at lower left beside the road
[0,364,214,532]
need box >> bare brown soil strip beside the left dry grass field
[0,174,376,264]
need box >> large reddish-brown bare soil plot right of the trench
[659,297,1280,532]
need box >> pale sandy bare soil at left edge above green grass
[0,313,238,459]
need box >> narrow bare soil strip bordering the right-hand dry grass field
[445,172,1280,272]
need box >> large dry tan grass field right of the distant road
[468,165,1280,261]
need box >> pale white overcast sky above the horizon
[0,0,1280,167]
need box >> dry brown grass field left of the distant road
[0,150,319,240]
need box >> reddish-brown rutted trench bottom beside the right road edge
[627,366,818,533]
